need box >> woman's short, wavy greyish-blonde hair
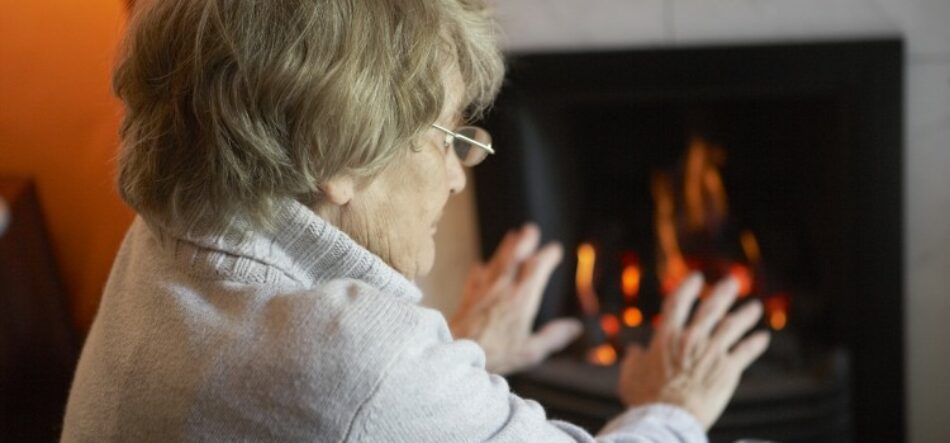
[115,0,503,278]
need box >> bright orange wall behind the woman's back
[0,0,131,329]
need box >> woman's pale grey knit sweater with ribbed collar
[62,202,706,443]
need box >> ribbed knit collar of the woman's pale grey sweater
[162,199,422,303]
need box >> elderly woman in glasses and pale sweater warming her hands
[63,0,768,442]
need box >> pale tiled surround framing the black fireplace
[421,0,950,443]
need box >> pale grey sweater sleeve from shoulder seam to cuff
[347,308,706,443]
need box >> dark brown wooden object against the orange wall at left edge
[0,178,79,442]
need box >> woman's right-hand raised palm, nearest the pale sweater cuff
[619,275,769,430]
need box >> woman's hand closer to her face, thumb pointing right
[449,224,582,374]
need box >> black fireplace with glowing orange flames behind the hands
[475,39,904,442]
